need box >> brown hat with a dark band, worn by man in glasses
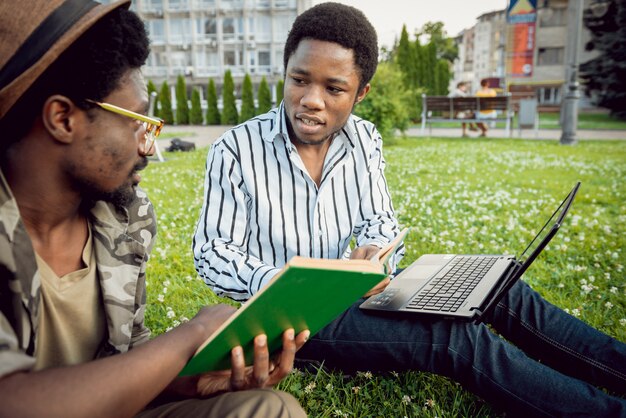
[0,0,130,119]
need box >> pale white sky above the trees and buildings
[314,0,508,47]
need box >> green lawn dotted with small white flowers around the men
[142,138,626,417]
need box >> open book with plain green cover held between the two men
[180,229,408,376]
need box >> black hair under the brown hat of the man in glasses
[0,7,150,143]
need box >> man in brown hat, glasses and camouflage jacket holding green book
[0,0,307,417]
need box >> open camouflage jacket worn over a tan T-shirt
[0,172,156,376]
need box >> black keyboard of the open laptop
[406,256,498,312]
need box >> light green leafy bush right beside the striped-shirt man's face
[355,62,416,141]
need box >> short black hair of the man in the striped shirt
[283,2,378,90]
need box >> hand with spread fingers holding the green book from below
[197,329,310,396]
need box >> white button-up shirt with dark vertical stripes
[193,104,404,301]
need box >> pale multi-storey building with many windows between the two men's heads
[116,0,312,94]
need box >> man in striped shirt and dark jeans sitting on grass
[193,3,626,416]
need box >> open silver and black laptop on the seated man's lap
[360,182,580,323]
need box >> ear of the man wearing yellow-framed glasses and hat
[41,94,85,144]
